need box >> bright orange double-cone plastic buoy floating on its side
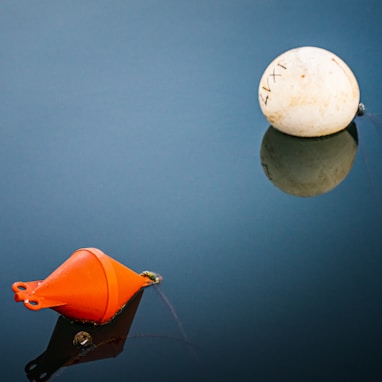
[12,248,162,324]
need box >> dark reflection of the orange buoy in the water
[25,290,143,381]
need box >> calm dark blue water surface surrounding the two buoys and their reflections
[0,0,382,382]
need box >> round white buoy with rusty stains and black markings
[259,46,360,137]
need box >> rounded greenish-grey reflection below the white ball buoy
[260,122,358,197]
